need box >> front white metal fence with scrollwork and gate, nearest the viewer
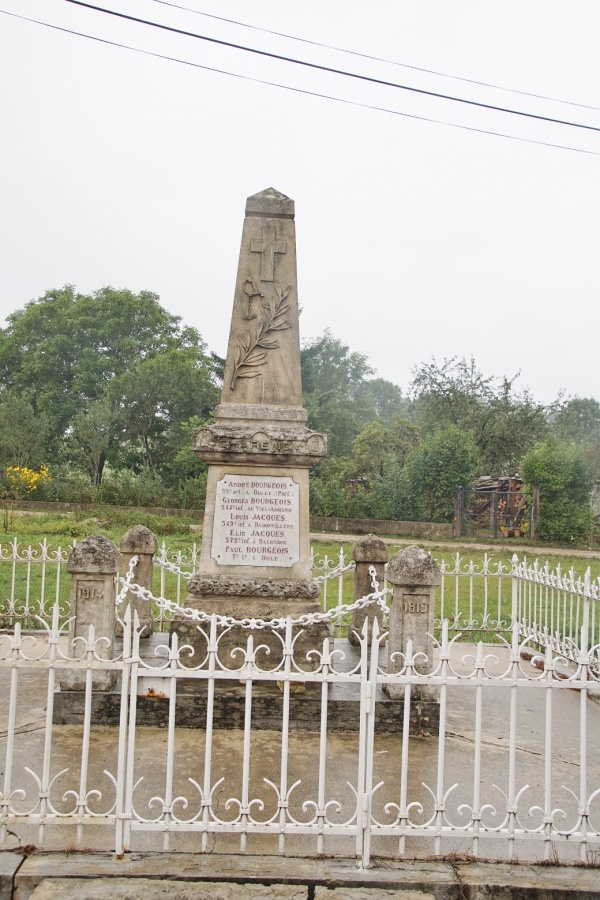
[0,598,600,865]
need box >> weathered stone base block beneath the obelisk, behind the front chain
[170,595,333,672]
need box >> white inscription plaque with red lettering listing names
[211,475,300,567]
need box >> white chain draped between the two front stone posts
[117,557,391,629]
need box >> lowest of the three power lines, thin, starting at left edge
[0,9,600,156]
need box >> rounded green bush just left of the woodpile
[401,425,478,522]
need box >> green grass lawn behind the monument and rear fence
[0,507,600,639]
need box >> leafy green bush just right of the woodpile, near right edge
[521,437,592,541]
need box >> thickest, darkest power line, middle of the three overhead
[65,0,600,132]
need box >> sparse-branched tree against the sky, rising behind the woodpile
[411,357,548,474]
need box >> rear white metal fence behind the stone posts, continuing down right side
[0,538,600,659]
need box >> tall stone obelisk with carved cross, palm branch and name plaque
[173,188,327,647]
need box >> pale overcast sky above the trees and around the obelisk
[0,0,600,402]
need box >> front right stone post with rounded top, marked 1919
[383,546,440,700]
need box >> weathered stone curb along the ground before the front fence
[10,852,600,900]
